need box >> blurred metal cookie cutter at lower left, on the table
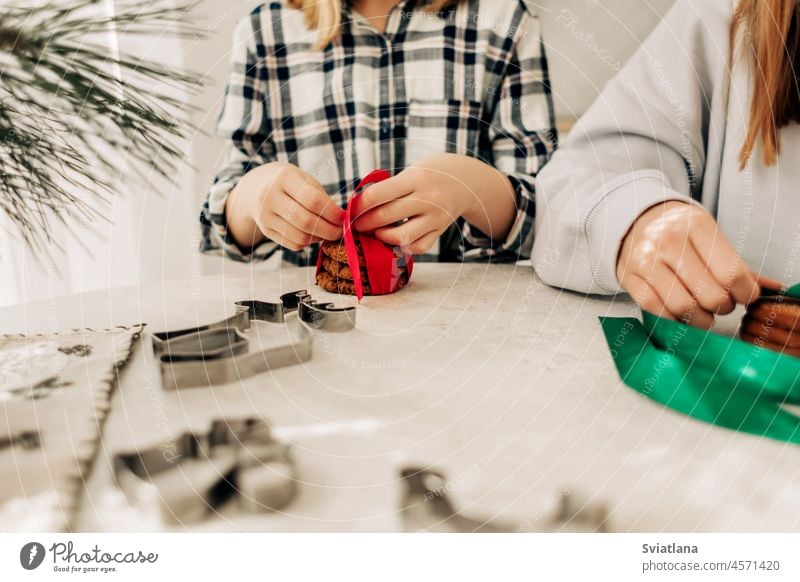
[114,418,297,523]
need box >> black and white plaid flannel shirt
[200,0,556,265]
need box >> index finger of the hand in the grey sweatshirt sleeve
[689,214,761,305]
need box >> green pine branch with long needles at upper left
[0,0,206,252]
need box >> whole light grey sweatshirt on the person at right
[533,0,800,294]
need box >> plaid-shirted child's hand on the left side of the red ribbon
[225,162,344,251]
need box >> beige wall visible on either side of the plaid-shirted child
[192,0,674,273]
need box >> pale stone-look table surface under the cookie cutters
[0,264,800,532]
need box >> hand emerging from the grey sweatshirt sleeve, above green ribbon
[617,202,760,329]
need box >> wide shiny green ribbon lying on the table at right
[600,285,800,444]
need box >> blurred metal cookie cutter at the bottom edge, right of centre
[401,468,608,533]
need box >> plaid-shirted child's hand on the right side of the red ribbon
[353,154,516,254]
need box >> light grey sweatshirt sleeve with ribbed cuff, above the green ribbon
[532,0,732,294]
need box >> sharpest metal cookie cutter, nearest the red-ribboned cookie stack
[153,291,356,390]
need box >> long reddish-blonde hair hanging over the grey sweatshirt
[731,0,800,169]
